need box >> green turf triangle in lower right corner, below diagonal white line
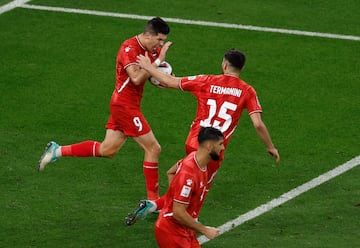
[206,165,360,248]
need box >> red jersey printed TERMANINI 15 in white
[179,74,262,148]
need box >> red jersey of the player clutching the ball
[111,36,160,108]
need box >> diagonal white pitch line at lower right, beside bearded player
[198,156,360,244]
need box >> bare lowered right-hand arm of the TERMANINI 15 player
[250,113,280,162]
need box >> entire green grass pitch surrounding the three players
[0,1,360,247]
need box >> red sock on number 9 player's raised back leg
[61,140,100,157]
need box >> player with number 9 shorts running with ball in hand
[39,17,171,200]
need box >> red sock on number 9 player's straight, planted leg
[143,161,159,200]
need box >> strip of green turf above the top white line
[31,0,360,35]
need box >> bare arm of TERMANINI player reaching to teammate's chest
[136,53,180,89]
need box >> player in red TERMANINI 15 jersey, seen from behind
[127,49,280,224]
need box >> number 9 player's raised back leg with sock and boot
[39,129,126,171]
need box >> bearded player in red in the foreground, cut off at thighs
[155,127,225,248]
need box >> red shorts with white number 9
[106,105,151,137]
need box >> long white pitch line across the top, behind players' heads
[20,4,360,41]
